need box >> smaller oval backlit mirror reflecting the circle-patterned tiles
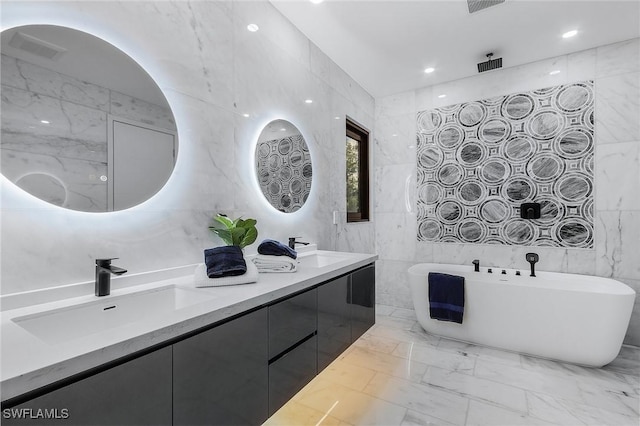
[256,120,312,213]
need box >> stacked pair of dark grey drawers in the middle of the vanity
[269,289,318,415]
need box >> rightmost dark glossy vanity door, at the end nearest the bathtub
[349,265,376,342]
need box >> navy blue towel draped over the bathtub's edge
[429,272,464,324]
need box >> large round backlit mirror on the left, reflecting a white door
[0,25,178,212]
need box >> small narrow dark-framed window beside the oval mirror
[347,119,369,222]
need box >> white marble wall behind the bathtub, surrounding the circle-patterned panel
[375,39,640,345]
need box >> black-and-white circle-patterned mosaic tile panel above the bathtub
[416,81,595,248]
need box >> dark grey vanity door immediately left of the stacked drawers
[173,308,269,425]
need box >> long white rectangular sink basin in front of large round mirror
[12,285,214,344]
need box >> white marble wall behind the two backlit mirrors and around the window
[0,0,374,294]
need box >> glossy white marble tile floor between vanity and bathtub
[265,305,640,426]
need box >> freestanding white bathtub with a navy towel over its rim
[409,263,636,367]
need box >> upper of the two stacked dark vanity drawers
[269,289,318,359]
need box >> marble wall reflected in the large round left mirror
[0,54,176,212]
